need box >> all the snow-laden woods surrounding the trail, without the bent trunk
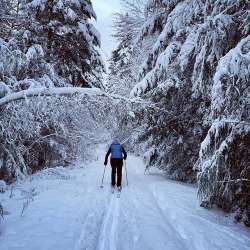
[0,0,250,226]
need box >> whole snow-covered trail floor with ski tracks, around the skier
[0,148,250,250]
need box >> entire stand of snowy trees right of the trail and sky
[110,0,250,225]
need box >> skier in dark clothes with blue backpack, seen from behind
[104,139,127,191]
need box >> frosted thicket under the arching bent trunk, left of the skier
[0,88,130,182]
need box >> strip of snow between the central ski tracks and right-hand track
[121,168,187,250]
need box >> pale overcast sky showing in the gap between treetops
[92,0,121,64]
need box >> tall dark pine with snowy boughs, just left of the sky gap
[26,0,103,87]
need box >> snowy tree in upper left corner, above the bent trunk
[0,0,66,93]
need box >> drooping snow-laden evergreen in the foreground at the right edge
[198,36,250,225]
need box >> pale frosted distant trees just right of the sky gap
[108,0,157,96]
